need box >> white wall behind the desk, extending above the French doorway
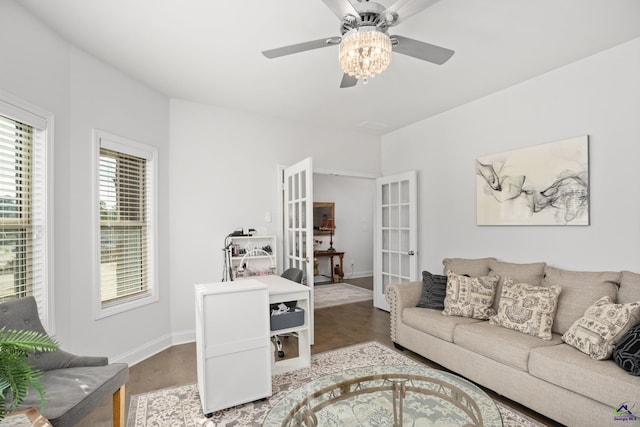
[170,100,380,341]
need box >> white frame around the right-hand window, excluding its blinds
[92,129,160,319]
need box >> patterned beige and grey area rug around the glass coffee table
[127,342,543,427]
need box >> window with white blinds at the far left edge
[0,115,48,314]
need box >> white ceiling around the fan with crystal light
[19,0,640,134]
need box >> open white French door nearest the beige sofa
[373,171,419,311]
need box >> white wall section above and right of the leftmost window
[0,1,71,338]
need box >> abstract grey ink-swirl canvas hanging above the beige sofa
[476,135,589,225]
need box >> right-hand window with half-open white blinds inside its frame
[98,130,155,310]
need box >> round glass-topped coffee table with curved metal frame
[262,365,502,427]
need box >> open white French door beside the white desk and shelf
[283,157,314,344]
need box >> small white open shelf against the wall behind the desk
[227,235,278,280]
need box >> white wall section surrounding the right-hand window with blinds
[68,49,171,360]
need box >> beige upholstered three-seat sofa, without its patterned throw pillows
[386,258,640,427]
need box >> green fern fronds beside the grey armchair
[0,327,58,419]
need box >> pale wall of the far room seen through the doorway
[313,174,375,278]
